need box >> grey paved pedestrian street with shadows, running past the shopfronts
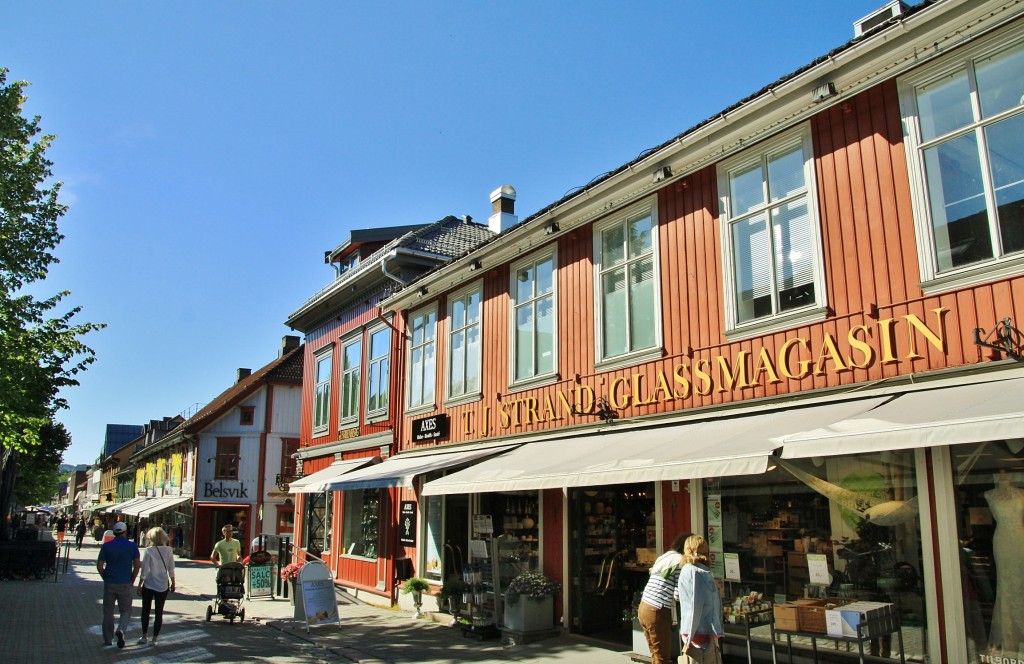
[0,542,630,664]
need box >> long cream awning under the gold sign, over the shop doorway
[423,399,884,496]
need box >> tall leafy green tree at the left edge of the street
[0,68,103,539]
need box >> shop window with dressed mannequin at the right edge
[951,439,1024,662]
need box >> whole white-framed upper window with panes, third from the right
[594,199,662,364]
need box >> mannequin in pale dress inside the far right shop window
[985,470,1024,653]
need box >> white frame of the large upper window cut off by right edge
[898,27,1024,295]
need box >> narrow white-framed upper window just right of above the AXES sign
[447,284,482,401]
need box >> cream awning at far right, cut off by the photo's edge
[782,378,1024,459]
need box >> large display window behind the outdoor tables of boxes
[703,450,928,661]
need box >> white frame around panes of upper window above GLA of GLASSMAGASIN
[594,196,664,370]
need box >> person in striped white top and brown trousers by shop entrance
[637,533,690,664]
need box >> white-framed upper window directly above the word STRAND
[509,253,555,383]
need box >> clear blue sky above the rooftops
[0,0,886,463]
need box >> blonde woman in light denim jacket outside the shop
[678,535,724,664]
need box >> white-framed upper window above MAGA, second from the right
[718,125,824,330]
